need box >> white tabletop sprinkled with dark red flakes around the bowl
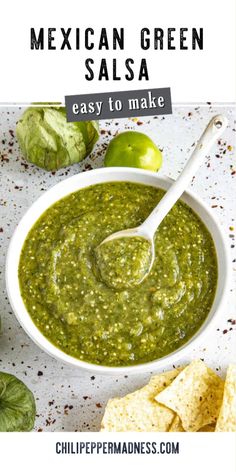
[0,105,236,431]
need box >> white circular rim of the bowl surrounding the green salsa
[5,167,230,374]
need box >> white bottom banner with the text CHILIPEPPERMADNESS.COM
[0,433,236,472]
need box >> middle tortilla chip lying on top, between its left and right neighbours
[156,360,224,431]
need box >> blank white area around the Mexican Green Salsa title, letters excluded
[0,0,236,102]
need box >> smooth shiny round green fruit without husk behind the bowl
[104,131,162,172]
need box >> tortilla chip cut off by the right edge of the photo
[215,364,236,432]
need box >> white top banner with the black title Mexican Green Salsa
[0,0,236,103]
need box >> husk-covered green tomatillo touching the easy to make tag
[16,107,99,171]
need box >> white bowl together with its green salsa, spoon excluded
[7,168,230,371]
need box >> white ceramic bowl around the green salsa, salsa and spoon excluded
[6,167,229,374]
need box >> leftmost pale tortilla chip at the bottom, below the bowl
[101,369,180,432]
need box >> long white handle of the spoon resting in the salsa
[141,115,228,237]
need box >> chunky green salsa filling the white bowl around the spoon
[19,182,217,366]
